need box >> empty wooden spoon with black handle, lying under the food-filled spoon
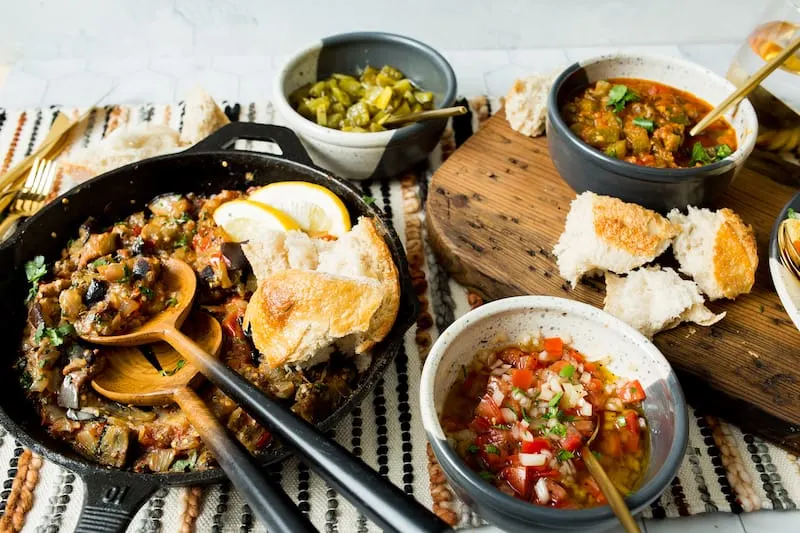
[92,313,317,532]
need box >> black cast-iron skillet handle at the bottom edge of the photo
[75,474,158,533]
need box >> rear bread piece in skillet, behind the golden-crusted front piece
[318,217,400,353]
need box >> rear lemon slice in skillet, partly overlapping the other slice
[249,181,350,237]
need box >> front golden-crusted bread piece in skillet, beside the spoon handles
[244,270,383,368]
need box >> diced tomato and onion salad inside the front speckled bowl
[441,337,647,509]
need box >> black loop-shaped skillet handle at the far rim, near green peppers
[186,122,313,165]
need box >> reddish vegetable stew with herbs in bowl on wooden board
[561,78,737,168]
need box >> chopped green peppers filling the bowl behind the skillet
[289,65,433,133]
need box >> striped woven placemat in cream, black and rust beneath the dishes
[0,97,800,533]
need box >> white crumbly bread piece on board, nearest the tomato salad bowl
[604,267,725,338]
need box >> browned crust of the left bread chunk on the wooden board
[594,196,677,260]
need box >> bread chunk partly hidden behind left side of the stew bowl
[505,74,555,137]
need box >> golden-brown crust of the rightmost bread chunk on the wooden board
[714,209,758,299]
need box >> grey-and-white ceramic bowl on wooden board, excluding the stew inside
[547,54,758,212]
